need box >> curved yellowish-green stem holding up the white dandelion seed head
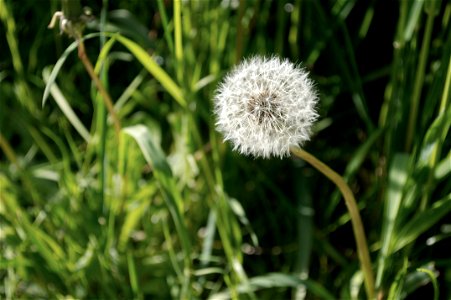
[290,147,374,299]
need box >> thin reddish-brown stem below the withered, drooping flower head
[77,38,121,141]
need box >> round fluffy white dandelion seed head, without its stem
[214,56,318,158]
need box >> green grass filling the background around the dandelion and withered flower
[0,0,451,299]
